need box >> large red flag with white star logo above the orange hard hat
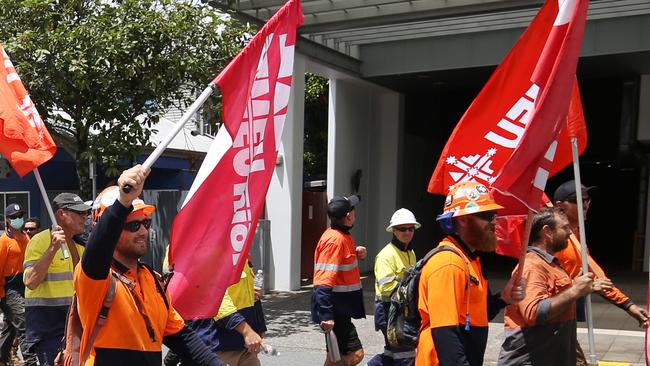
[428,0,588,213]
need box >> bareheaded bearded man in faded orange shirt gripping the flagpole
[498,208,612,366]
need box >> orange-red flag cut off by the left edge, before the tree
[0,43,56,177]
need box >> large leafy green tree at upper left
[0,0,251,197]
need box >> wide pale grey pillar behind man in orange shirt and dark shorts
[327,78,401,272]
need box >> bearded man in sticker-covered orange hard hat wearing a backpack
[415,182,525,366]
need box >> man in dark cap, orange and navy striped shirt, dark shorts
[311,195,367,366]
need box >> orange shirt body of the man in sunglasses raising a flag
[74,262,185,366]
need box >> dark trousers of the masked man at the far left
[0,289,38,366]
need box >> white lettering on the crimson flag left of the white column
[230,33,294,266]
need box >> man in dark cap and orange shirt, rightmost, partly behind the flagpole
[553,180,648,365]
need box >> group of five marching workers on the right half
[312,181,648,366]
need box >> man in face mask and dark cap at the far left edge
[0,203,37,365]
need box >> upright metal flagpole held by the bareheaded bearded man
[571,136,597,365]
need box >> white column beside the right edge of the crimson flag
[266,52,305,291]
